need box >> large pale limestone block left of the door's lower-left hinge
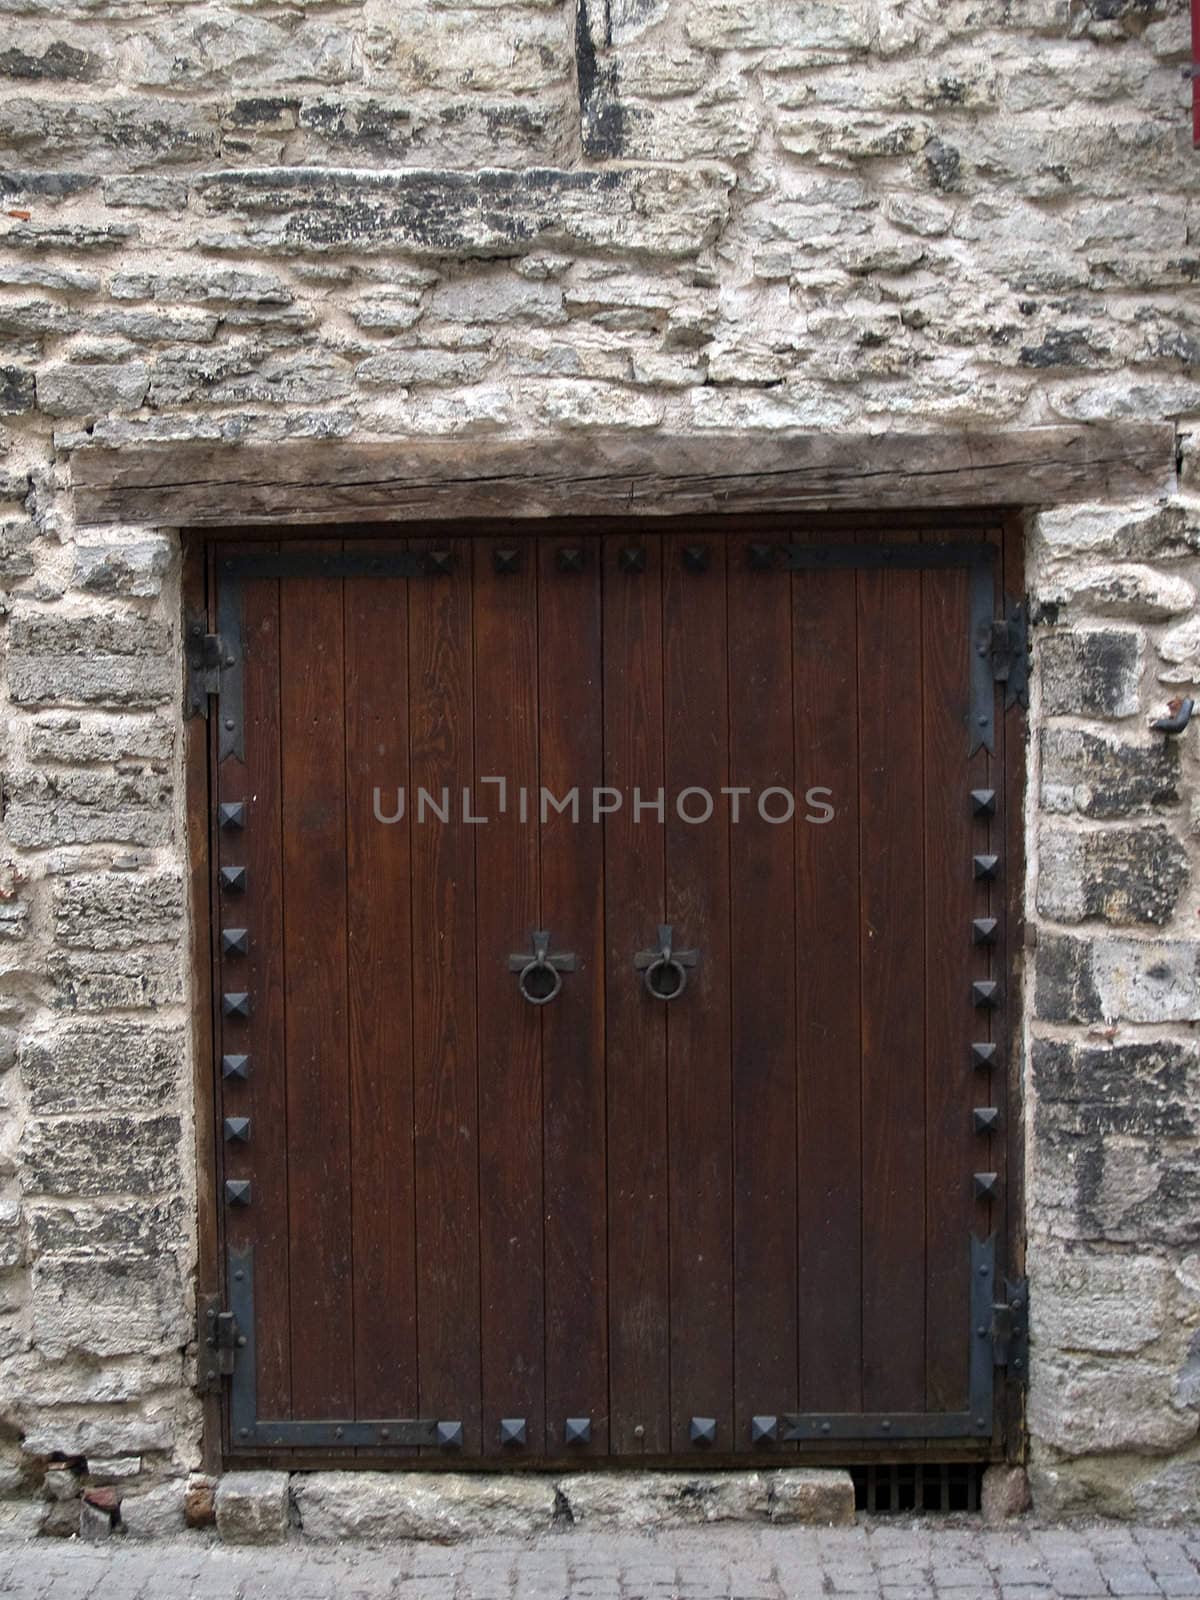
[32,1256,189,1360]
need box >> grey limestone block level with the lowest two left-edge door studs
[21,1114,181,1195]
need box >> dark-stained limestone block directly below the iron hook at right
[1040,726,1179,819]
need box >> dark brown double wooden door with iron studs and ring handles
[197,525,1008,1462]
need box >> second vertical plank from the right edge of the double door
[858,550,925,1411]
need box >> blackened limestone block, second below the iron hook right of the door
[1037,822,1190,926]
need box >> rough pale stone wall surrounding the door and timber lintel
[0,0,1200,1525]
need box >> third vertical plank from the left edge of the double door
[346,539,424,1418]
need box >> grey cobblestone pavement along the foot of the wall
[0,1523,1200,1600]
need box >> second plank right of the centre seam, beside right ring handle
[662,534,734,1454]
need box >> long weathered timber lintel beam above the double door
[72,422,1174,526]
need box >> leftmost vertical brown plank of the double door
[214,544,292,1420]
